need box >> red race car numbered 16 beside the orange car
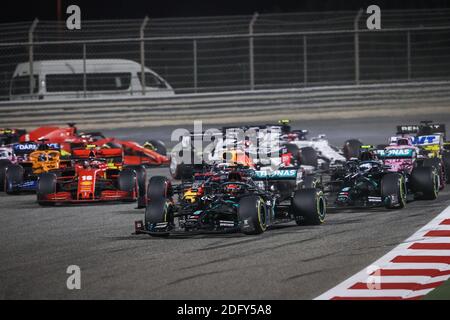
[36,149,140,205]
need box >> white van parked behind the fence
[10,59,174,100]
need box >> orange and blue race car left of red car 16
[0,143,70,194]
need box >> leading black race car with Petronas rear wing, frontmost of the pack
[135,165,326,236]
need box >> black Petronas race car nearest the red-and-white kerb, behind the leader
[315,149,439,209]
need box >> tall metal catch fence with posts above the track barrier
[0,9,450,100]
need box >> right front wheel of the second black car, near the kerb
[381,173,406,209]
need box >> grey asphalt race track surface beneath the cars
[0,114,450,299]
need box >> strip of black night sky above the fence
[0,0,450,22]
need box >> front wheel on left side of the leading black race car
[144,199,174,237]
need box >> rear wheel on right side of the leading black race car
[290,188,326,225]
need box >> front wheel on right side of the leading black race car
[238,195,267,234]
